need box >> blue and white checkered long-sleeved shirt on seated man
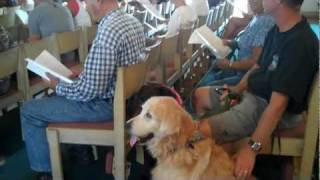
[56,9,145,101]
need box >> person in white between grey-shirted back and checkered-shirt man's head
[67,0,92,27]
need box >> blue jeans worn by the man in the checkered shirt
[20,96,113,172]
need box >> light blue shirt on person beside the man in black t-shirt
[237,14,275,59]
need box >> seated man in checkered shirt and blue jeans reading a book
[21,0,145,179]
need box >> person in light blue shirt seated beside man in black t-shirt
[200,0,274,86]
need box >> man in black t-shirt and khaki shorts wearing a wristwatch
[194,0,319,179]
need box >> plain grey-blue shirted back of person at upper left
[28,0,74,39]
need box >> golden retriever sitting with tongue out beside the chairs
[128,97,235,180]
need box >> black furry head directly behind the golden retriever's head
[126,82,180,119]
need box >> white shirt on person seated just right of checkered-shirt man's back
[166,6,198,38]
